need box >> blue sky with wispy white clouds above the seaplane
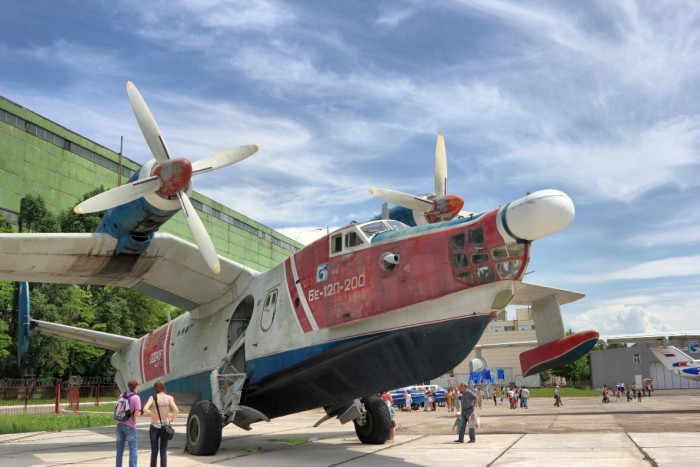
[0,0,700,335]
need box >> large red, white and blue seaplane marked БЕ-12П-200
[0,83,598,455]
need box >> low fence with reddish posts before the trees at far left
[0,376,119,416]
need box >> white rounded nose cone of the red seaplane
[502,190,574,241]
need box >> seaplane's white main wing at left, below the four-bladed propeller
[0,233,258,310]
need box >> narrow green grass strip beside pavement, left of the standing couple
[0,413,115,435]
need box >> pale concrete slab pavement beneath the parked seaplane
[0,390,700,467]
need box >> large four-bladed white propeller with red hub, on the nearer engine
[73,81,258,274]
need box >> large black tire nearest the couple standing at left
[187,401,223,456]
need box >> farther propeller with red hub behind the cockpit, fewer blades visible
[369,132,464,223]
